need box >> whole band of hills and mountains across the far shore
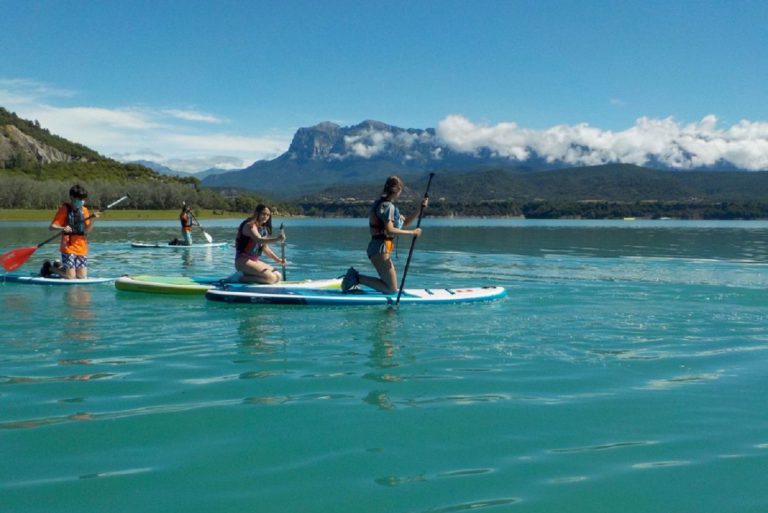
[0,107,768,219]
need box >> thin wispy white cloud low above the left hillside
[0,80,290,172]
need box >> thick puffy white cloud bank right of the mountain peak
[436,115,768,171]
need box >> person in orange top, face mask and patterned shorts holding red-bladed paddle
[50,184,100,280]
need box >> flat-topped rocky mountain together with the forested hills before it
[202,120,768,201]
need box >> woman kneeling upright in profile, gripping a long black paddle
[341,176,429,294]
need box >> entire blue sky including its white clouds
[0,0,768,172]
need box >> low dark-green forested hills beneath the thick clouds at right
[308,164,768,203]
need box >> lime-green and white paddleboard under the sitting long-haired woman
[115,273,341,295]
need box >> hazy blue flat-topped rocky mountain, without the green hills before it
[202,119,759,199]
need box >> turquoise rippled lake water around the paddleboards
[0,215,768,513]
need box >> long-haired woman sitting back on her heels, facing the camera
[235,205,285,284]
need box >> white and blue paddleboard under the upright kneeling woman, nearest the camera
[205,285,507,305]
